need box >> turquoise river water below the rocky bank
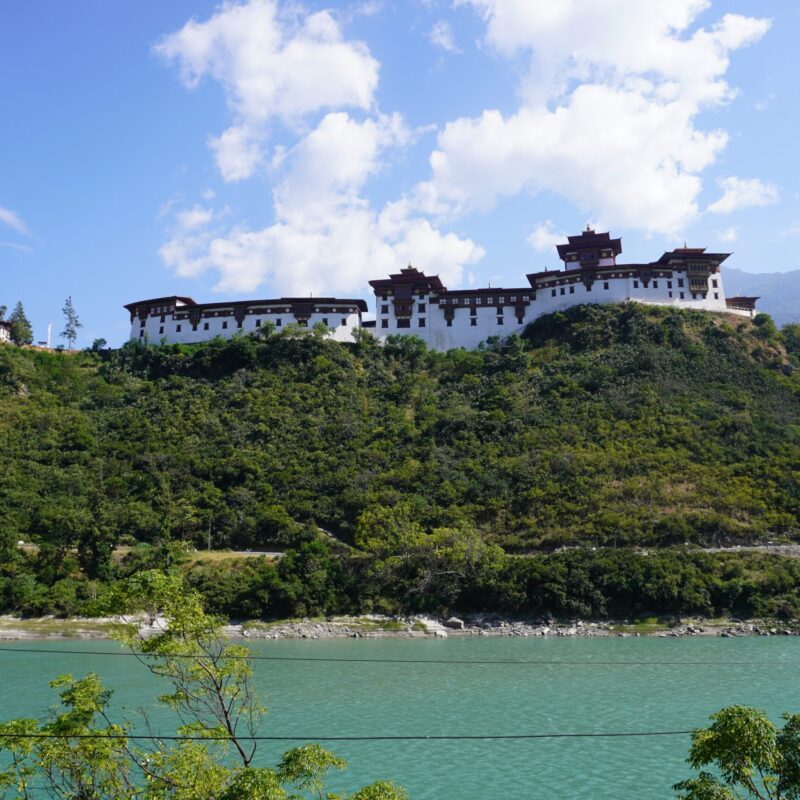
[0,637,800,800]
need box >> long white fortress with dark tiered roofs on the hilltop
[125,228,758,350]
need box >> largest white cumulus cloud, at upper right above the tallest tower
[428,0,770,234]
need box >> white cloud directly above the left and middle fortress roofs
[161,112,483,295]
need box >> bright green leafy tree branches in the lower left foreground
[0,572,407,800]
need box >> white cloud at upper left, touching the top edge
[159,0,378,180]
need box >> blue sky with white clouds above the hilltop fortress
[0,0,800,346]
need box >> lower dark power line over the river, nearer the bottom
[0,730,694,742]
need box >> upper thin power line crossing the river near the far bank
[0,647,798,668]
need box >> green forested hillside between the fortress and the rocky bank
[0,305,800,616]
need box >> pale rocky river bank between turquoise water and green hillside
[0,614,800,641]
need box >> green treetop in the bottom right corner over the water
[674,706,800,800]
